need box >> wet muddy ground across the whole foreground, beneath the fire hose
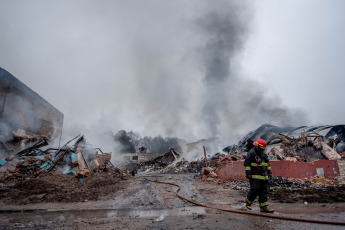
[0,172,345,229]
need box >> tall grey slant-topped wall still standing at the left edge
[0,68,63,145]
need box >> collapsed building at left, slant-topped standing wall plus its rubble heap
[0,68,126,185]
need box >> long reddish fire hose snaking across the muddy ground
[146,179,345,226]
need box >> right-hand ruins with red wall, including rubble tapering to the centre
[128,125,345,185]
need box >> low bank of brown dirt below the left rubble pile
[0,171,130,205]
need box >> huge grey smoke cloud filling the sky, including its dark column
[0,0,306,149]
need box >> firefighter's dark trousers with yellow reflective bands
[246,179,269,207]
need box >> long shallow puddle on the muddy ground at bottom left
[0,206,209,224]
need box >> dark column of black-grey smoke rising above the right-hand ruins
[195,1,307,136]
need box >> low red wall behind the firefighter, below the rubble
[216,160,340,181]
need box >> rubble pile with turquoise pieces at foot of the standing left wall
[0,135,128,185]
